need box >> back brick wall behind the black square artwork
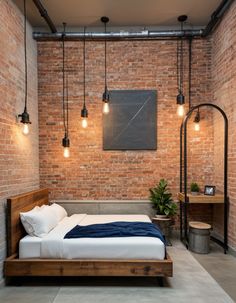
[38,40,213,214]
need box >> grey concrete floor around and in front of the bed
[0,240,236,303]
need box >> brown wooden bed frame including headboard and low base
[4,189,173,278]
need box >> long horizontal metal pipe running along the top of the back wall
[33,29,203,41]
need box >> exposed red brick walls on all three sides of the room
[0,0,236,280]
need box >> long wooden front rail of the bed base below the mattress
[5,256,173,277]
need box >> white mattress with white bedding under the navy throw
[19,214,165,260]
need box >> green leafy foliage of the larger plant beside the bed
[149,179,177,217]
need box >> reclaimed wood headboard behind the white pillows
[7,189,49,257]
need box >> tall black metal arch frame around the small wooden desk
[180,103,228,253]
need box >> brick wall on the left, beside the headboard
[0,0,39,281]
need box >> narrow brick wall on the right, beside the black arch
[212,2,236,249]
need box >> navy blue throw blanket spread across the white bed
[64,222,165,244]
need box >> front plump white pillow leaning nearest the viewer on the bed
[20,205,58,237]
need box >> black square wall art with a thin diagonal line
[103,90,157,150]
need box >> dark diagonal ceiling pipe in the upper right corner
[202,0,234,37]
